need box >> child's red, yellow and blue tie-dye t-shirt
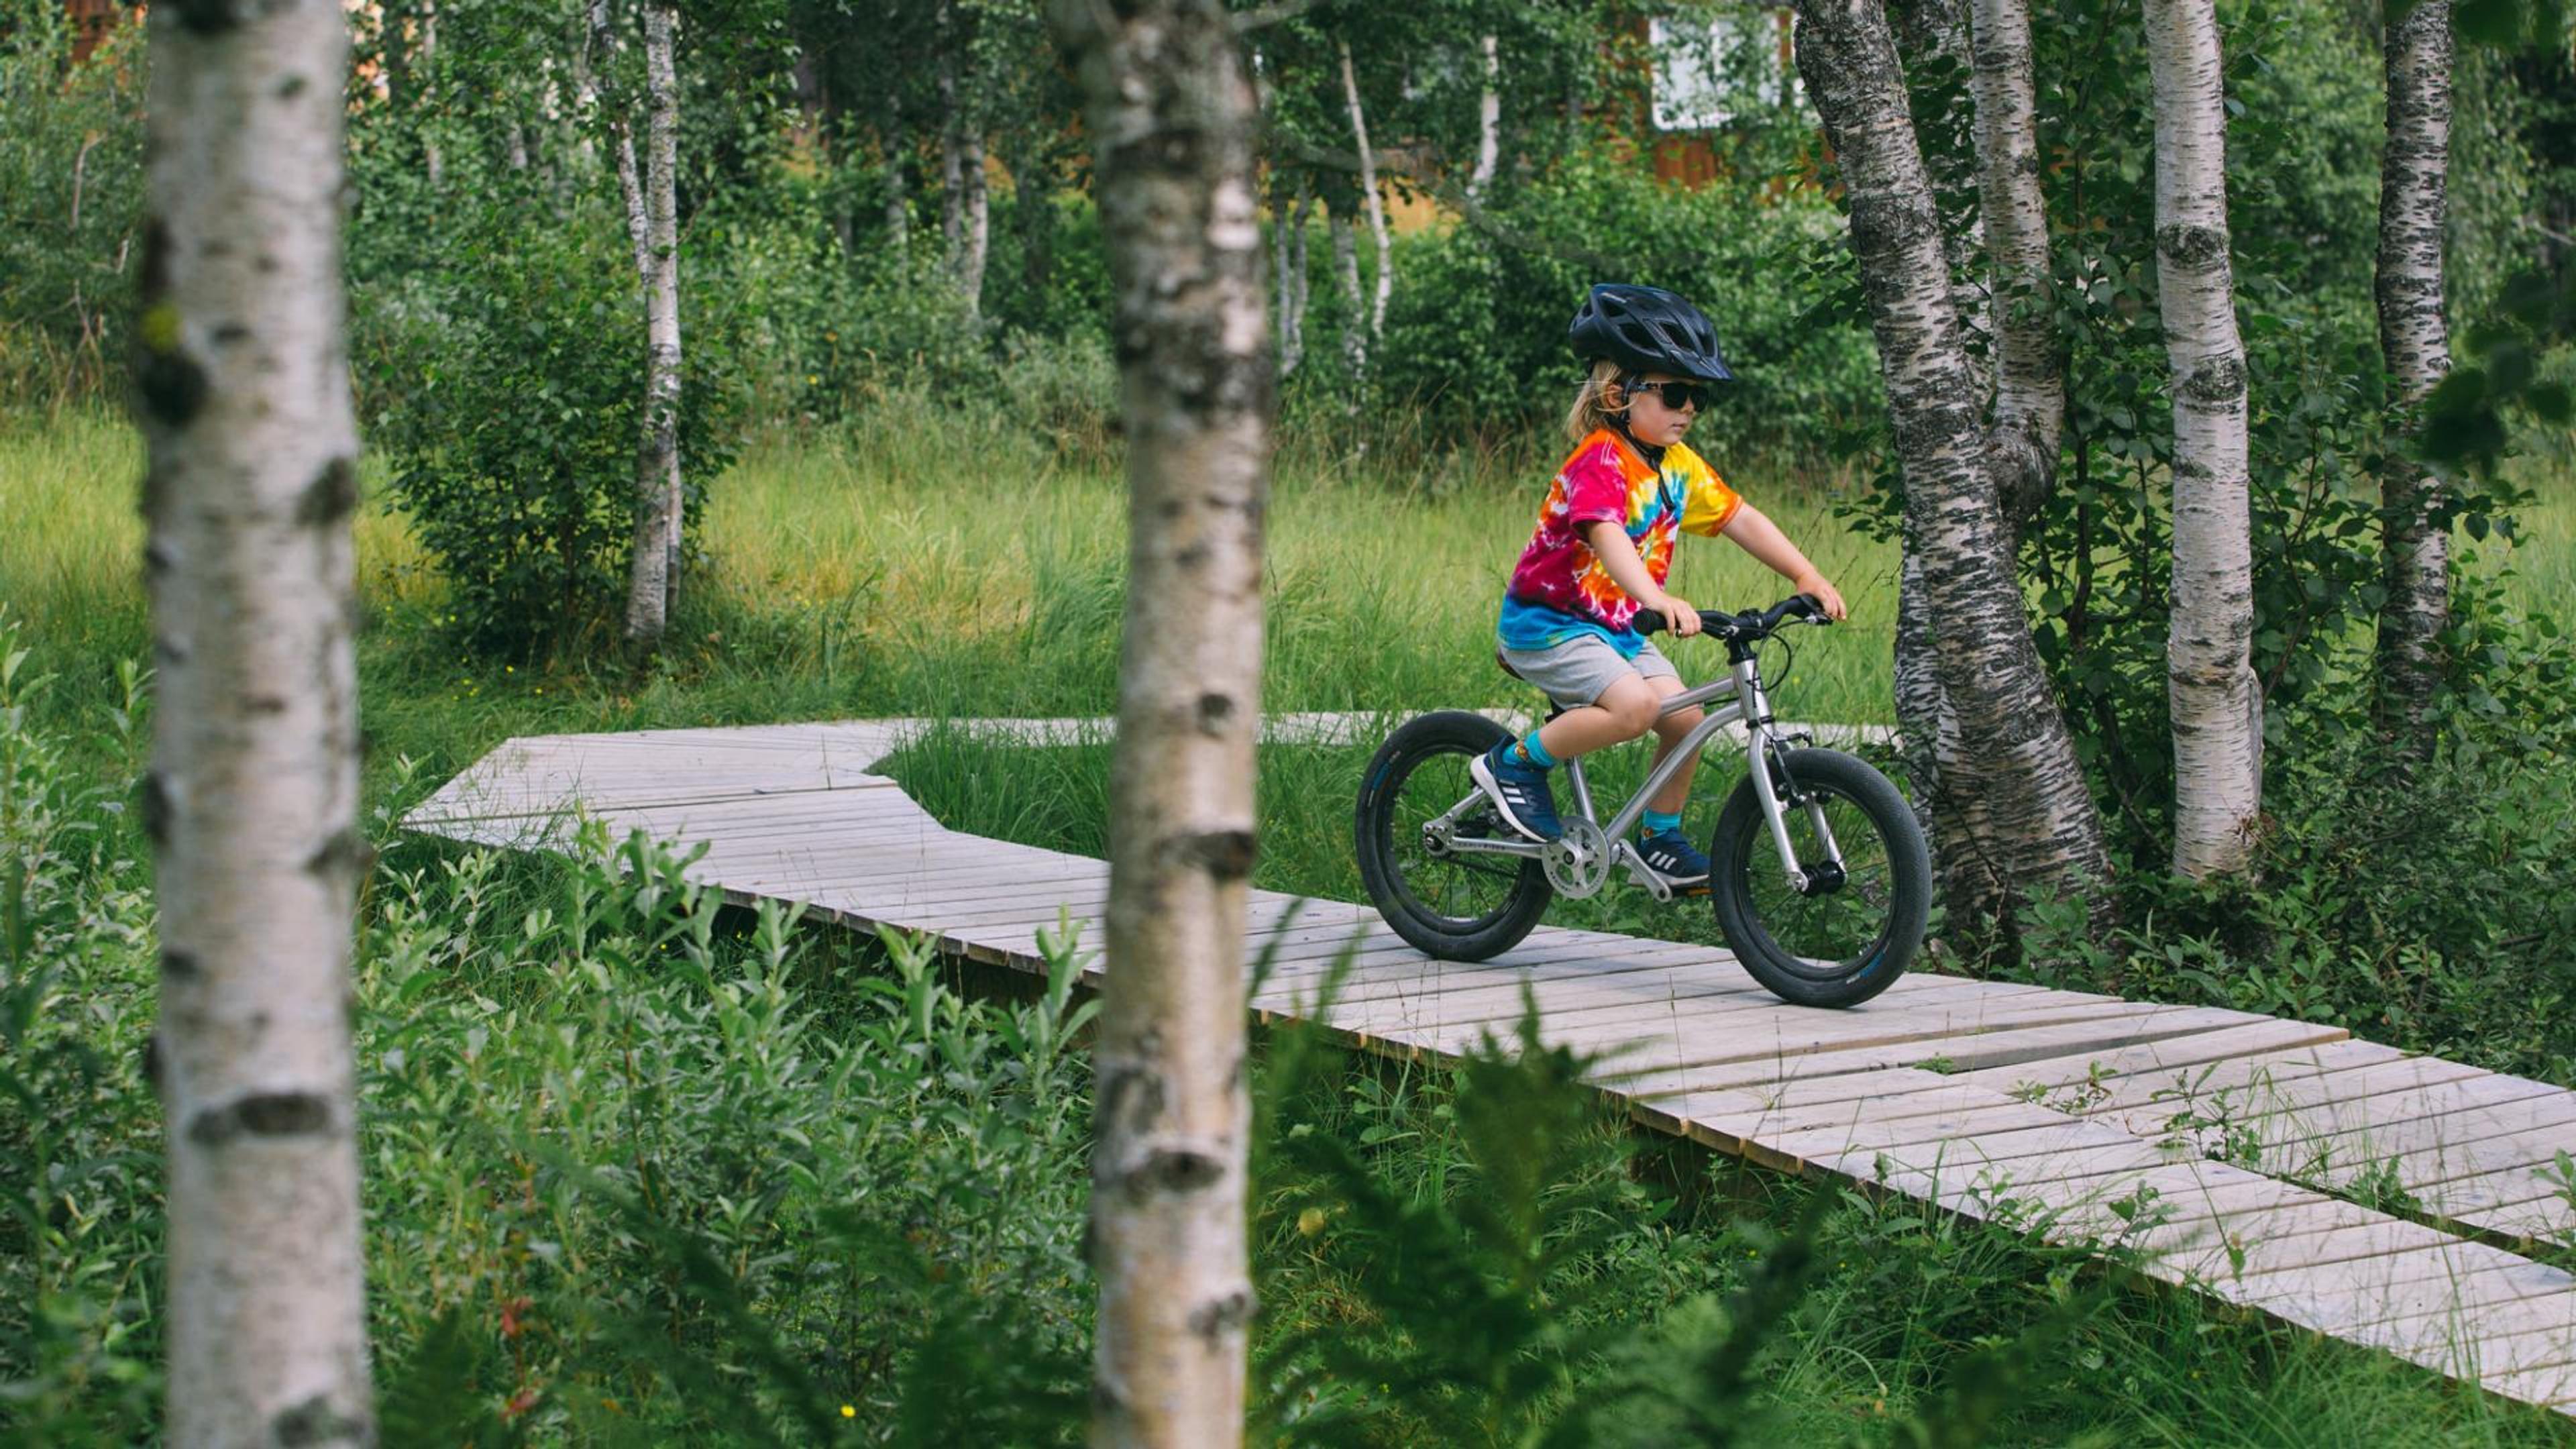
[1497,428,1744,657]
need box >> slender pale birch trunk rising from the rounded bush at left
[626,0,683,650]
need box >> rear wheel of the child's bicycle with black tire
[1355,709,1554,962]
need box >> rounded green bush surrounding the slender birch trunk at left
[358,206,739,657]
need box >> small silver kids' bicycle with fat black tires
[1355,593,1932,1006]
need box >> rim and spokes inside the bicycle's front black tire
[1731,782,1896,979]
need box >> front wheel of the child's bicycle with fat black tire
[1708,750,1932,1006]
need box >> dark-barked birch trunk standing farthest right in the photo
[2377,0,2453,761]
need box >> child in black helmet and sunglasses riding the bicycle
[1468,284,1847,890]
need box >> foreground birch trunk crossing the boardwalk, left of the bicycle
[1054,0,1273,1449]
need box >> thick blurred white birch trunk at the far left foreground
[134,3,376,1446]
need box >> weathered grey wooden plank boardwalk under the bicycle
[407,714,2576,1415]
